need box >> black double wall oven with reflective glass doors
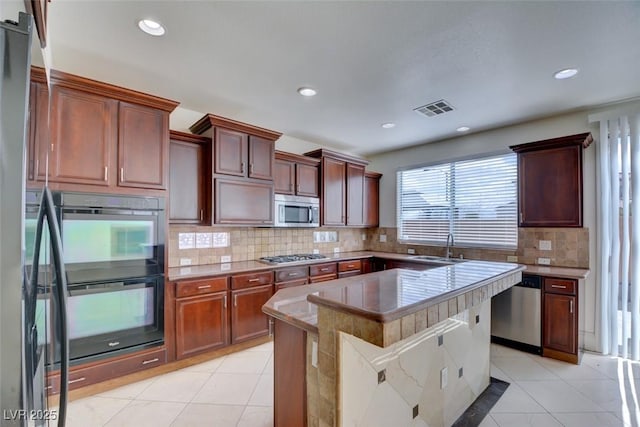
[25,192,165,364]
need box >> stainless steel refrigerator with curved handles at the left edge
[0,13,68,426]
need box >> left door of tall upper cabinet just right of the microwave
[322,157,346,225]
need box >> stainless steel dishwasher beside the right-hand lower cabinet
[491,274,542,354]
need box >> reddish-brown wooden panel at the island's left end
[273,319,307,427]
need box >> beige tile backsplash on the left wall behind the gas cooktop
[168,225,367,267]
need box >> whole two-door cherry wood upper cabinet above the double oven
[27,67,178,194]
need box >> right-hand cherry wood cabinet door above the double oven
[118,102,169,190]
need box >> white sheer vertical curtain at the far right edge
[589,106,640,360]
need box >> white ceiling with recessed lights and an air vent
[32,0,640,154]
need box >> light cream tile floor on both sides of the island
[67,343,640,427]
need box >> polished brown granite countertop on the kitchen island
[263,258,524,333]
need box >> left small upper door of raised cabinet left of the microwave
[213,128,248,176]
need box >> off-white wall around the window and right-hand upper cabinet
[368,111,599,350]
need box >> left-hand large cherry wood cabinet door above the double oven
[49,86,118,186]
